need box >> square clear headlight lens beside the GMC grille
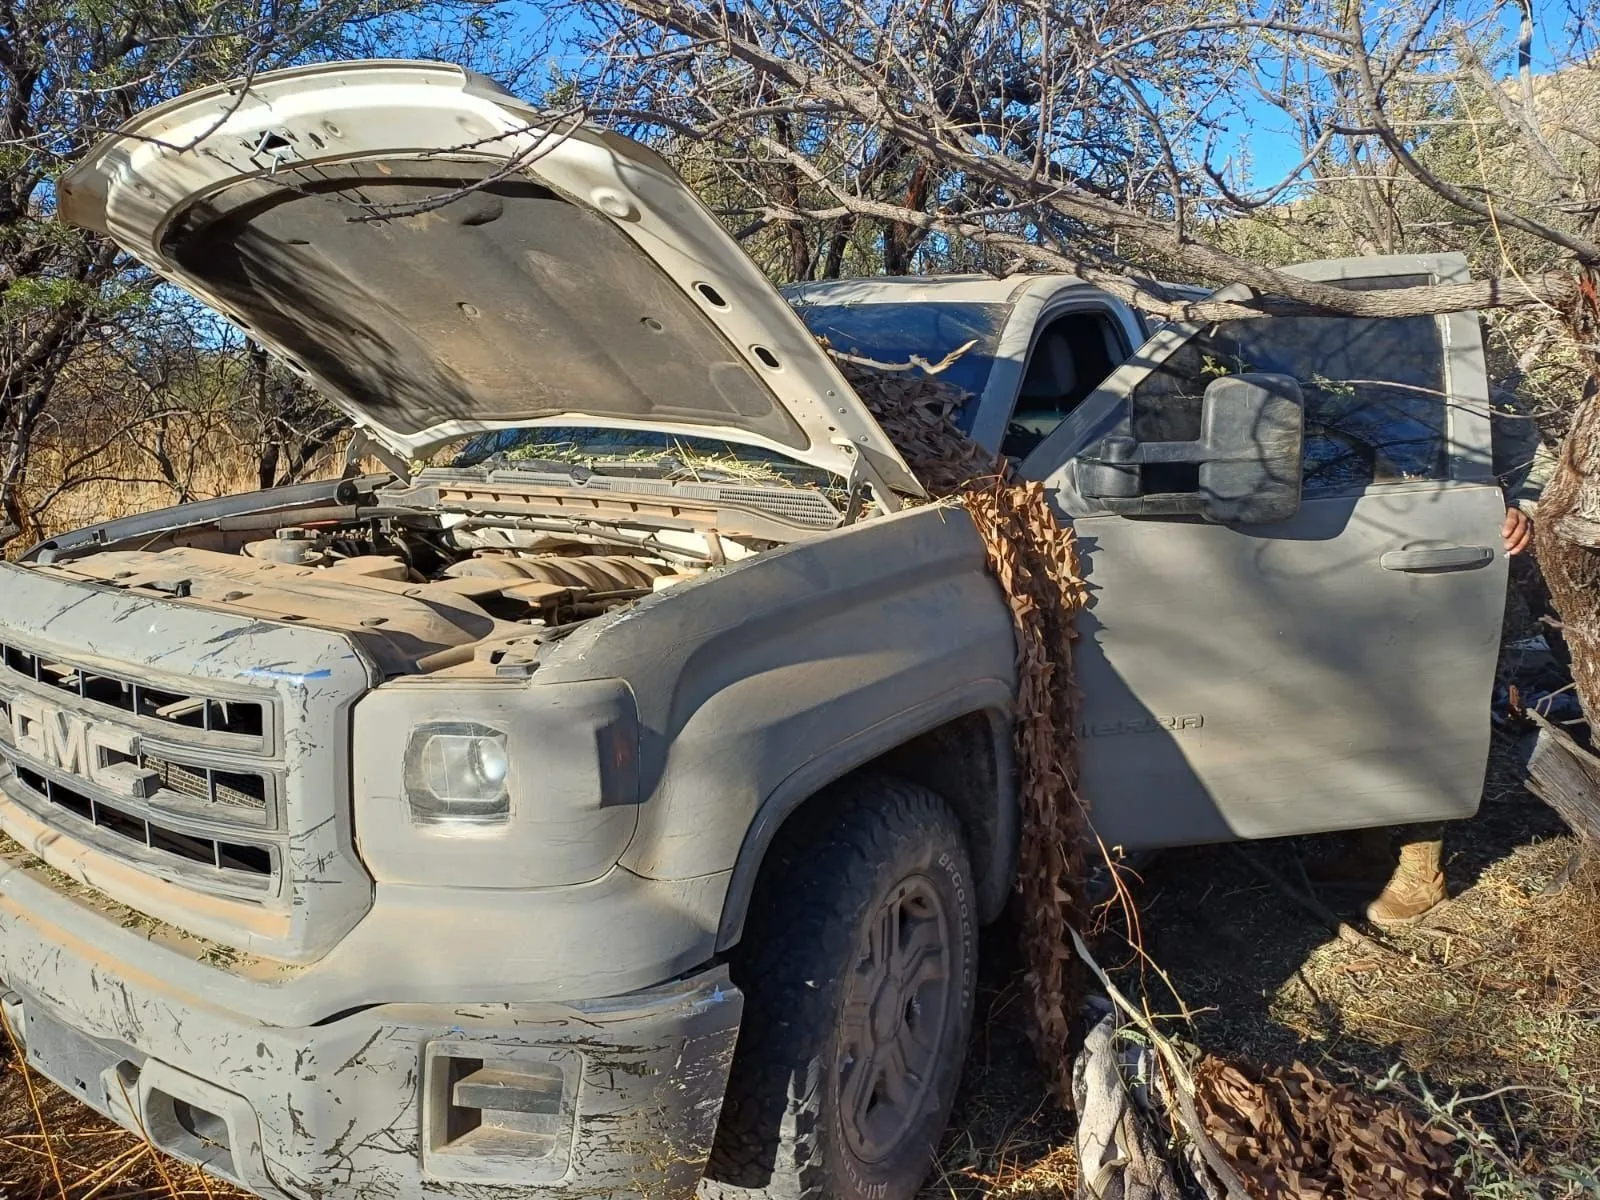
[405,722,510,826]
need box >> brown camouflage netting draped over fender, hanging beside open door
[840,352,1091,1104]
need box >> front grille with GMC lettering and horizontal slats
[0,643,282,901]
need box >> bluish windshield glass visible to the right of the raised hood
[795,301,1011,429]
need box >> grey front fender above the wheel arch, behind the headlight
[539,506,1016,928]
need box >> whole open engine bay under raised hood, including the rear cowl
[19,467,848,677]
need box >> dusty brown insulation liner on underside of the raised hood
[163,158,808,450]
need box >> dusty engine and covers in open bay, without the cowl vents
[26,514,752,675]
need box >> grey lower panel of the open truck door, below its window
[1075,482,1506,848]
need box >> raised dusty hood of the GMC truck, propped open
[59,61,922,499]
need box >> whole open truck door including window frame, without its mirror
[1022,256,1506,848]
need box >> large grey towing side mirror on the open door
[1077,374,1306,525]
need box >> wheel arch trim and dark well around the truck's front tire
[717,680,1018,950]
